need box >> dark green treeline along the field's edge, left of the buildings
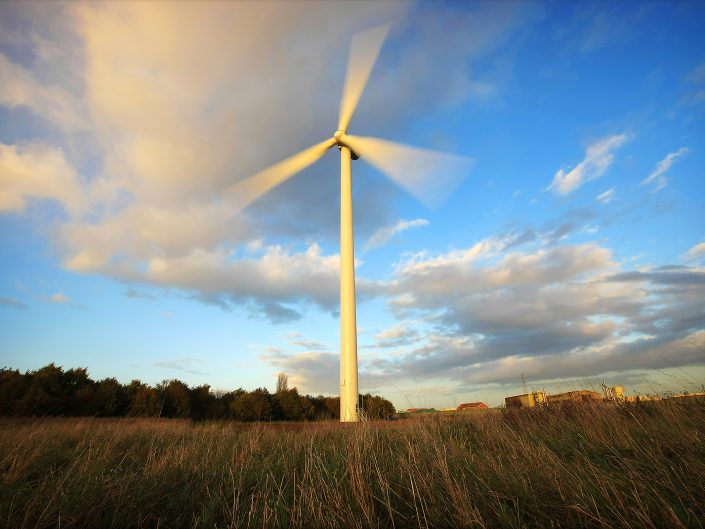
[0,363,395,422]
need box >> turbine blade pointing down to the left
[225,138,336,211]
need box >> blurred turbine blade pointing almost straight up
[338,25,389,130]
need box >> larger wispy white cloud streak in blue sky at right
[548,133,629,195]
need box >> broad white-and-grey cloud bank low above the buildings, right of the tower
[372,244,705,384]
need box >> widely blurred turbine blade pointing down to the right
[343,135,475,209]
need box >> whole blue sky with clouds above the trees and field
[0,2,705,408]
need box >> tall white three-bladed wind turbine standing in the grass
[225,25,474,422]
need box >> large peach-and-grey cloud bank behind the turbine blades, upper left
[0,2,531,322]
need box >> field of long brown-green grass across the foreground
[0,398,705,529]
